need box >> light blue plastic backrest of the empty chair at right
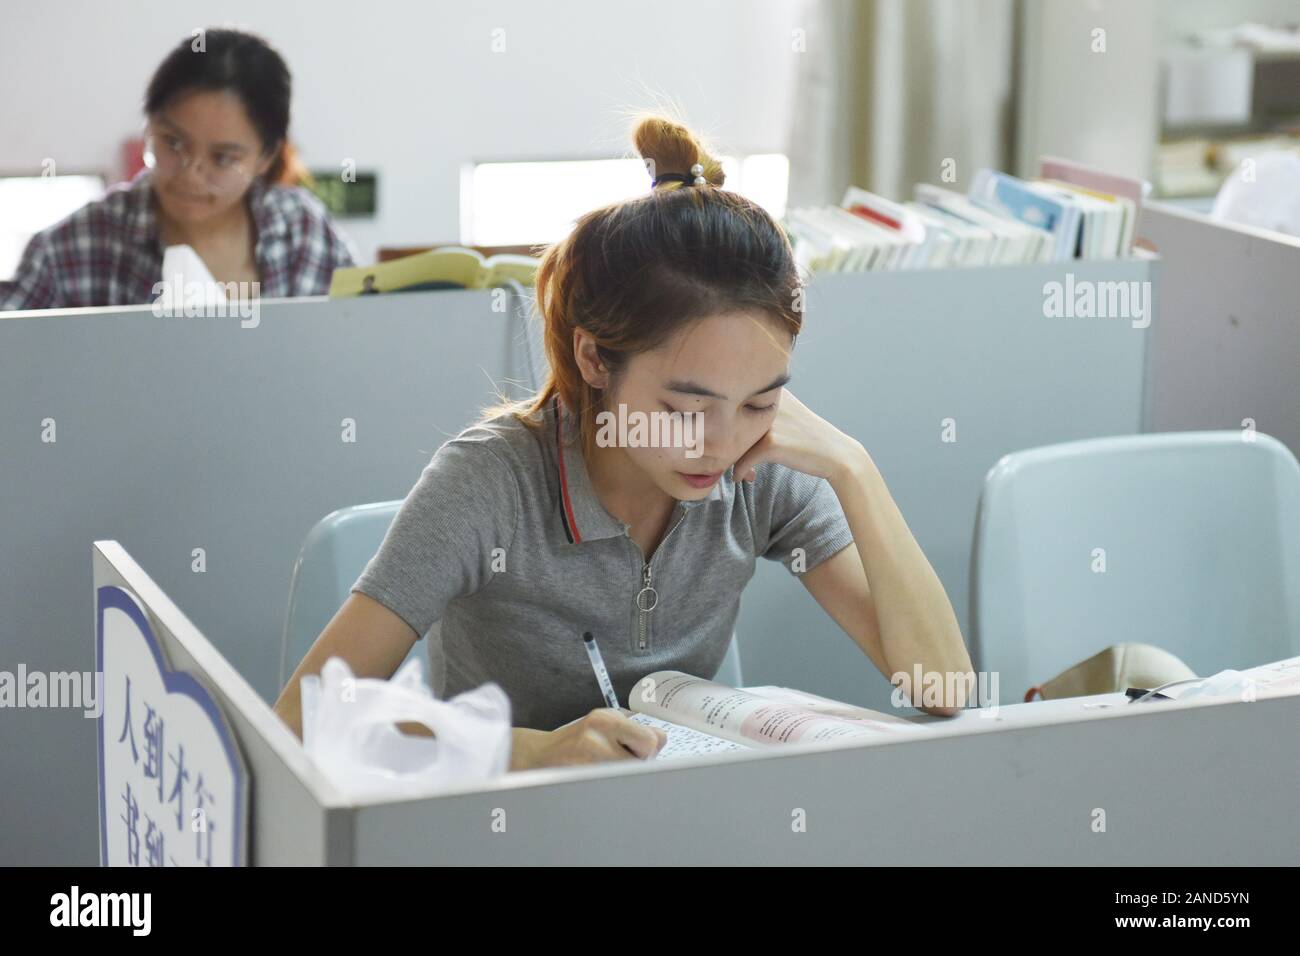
[970,432,1300,702]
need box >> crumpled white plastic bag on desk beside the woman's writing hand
[302,657,511,799]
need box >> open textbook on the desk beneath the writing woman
[628,671,924,760]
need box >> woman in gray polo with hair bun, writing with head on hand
[276,117,971,769]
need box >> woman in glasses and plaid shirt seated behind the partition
[0,30,352,310]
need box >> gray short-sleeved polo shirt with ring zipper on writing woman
[352,402,853,730]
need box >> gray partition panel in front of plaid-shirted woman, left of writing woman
[0,291,532,865]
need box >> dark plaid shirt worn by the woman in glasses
[0,169,354,310]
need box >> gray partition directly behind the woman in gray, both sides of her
[0,259,1158,864]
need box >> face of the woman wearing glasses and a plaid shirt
[148,91,272,226]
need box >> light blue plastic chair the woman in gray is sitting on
[277,499,741,687]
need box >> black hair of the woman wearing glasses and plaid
[144,30,293,182]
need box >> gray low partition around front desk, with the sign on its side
[92,541,1300,866]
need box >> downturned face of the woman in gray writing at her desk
[598,312,793,501]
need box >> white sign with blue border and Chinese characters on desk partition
[95,587,248,866]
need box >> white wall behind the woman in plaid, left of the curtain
[0,0,797,256]
